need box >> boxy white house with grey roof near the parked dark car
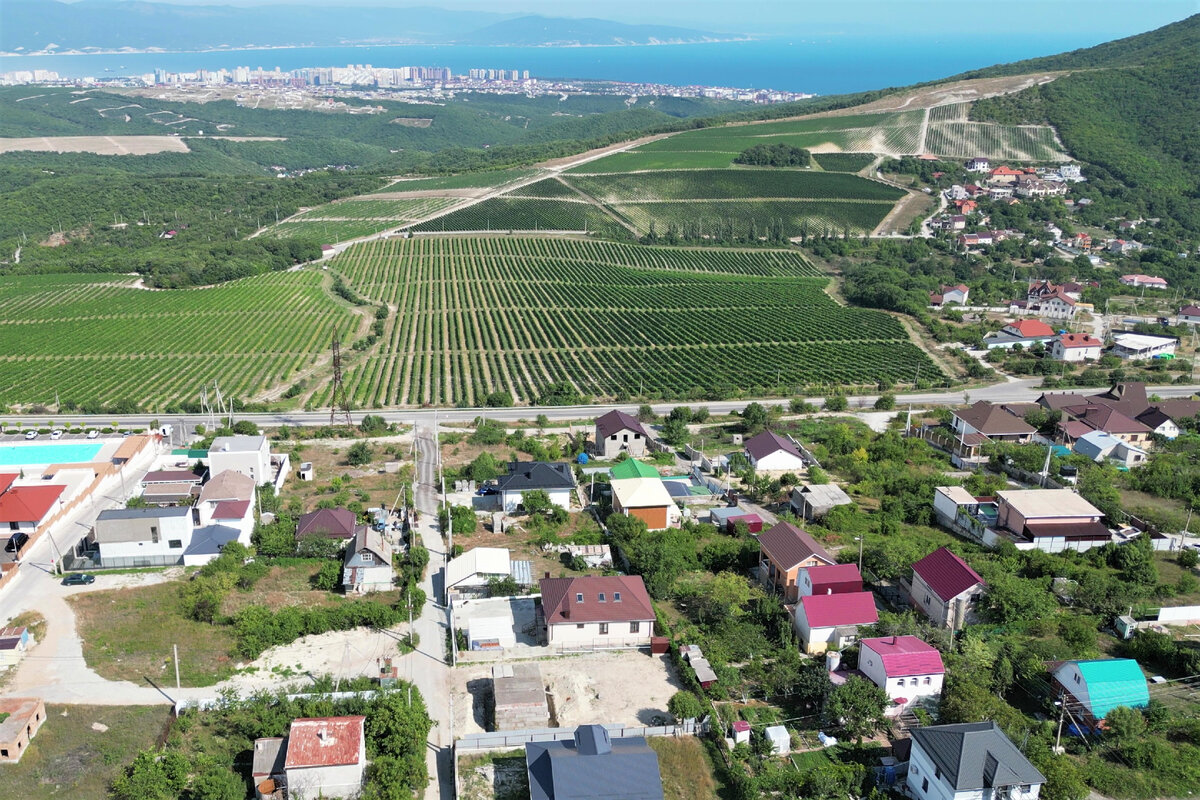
[90,506,192,567]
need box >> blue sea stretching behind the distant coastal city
[0,30,1118,95]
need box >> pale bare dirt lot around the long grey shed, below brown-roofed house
[451,651,683,735]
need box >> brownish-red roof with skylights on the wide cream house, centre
[539,575,654,625]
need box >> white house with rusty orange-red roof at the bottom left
[283,716,367,800]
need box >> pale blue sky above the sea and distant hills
[49,0,1200,38]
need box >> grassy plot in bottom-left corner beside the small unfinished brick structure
[0,705,170,800]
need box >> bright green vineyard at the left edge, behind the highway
[0,272,359,410]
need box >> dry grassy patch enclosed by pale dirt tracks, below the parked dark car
[70,582,236,686]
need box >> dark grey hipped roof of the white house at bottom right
[912,721,1045,792]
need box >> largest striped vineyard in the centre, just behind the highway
[328,236,938,407]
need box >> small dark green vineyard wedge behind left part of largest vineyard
[412,197,624,236]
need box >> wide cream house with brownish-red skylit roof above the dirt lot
[536,575,654,650]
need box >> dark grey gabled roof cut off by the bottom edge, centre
[526,724,662,800]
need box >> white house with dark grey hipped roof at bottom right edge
[906,721,1045,800]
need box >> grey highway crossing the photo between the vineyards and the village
[18,378,1200,439]
